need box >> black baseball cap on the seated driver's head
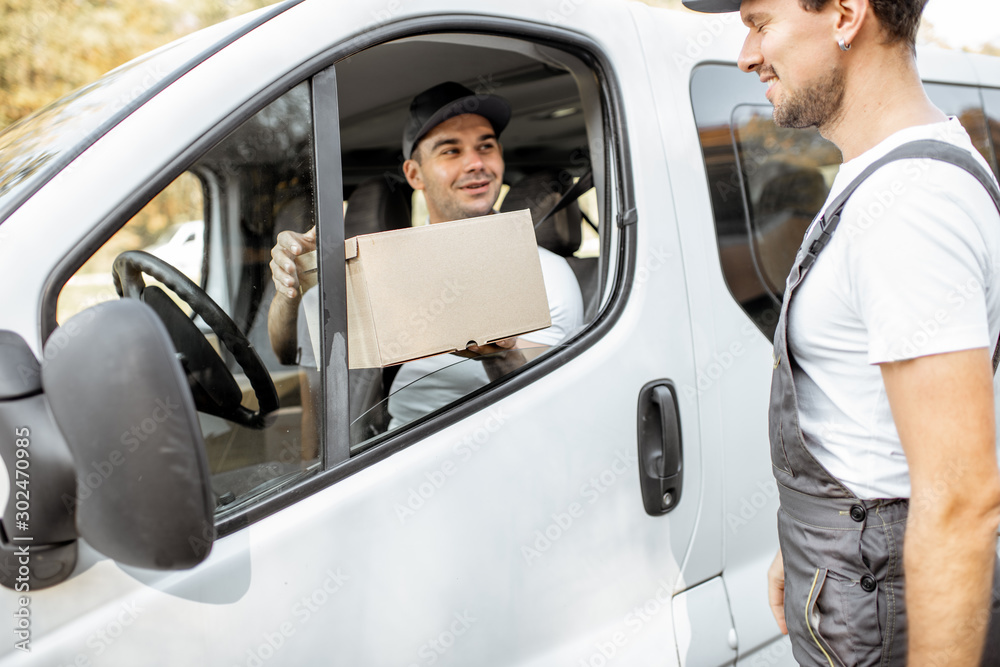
[403,81,511,160]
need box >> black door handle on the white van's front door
[637,380,684,516]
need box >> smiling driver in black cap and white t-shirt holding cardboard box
[268,81,583,428]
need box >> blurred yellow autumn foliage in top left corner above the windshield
[0,0,274,128]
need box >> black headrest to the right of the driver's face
[500,170,582,257]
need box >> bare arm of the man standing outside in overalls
[881,349,1000,666]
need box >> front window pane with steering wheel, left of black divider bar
[57,82,322,516]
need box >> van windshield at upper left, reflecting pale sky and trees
[0,11,272,224]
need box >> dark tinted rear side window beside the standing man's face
[691,65,841,337]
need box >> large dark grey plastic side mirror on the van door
[0,299,215,588]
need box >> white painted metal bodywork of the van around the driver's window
[0,0,1000,667]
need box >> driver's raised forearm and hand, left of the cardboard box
[267,227,316,364]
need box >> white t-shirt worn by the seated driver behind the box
[389,247,583,429]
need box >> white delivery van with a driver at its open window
[0,0,1000,667]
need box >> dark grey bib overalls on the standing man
[769,141,1000,667]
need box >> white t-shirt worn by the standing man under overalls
[788,118,1000,498]
